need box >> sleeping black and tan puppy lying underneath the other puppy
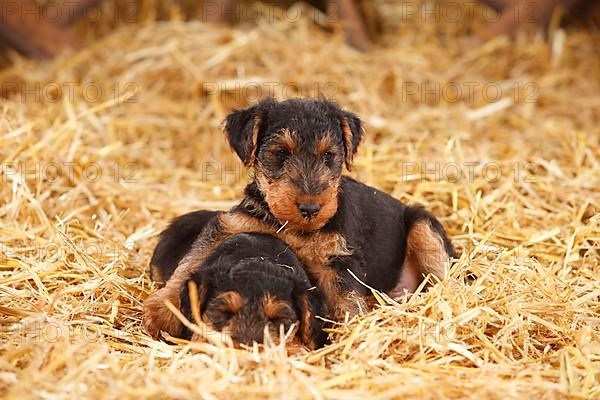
[150,211,327,349]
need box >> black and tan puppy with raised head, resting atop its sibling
[143,99,455,336]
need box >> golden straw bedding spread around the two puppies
[0,1,600,399]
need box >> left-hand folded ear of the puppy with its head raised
[223,98,275,167]
